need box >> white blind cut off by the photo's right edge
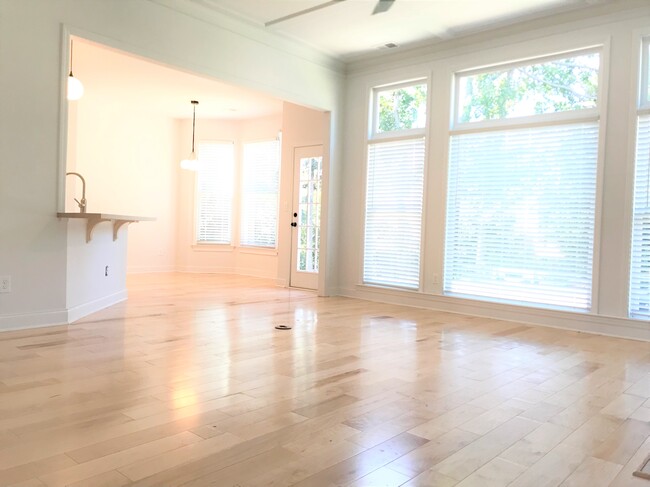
[629,115,650,319]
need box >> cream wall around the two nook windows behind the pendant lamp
[177,114,282,279]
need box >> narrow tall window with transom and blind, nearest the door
[363,81,427,289]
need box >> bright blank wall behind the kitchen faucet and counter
[66,92,178,272]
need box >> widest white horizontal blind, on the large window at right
[444,122,598,309]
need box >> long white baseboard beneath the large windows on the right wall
[339,285,650,341]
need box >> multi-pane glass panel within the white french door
[296,157,323,273]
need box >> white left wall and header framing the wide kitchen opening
[0,0,343,328]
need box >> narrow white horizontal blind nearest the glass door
[363,137,425,289]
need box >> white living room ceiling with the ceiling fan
[186,0,615,60]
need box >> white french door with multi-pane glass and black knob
[290,145,323,289]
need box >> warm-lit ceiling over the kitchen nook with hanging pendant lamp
[72,37,282,120]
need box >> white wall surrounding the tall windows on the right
[338,2,650,339]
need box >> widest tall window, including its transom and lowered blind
[444,51,600,310]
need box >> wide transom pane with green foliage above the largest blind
[458,53,600,122]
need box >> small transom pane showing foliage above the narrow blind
[377,84,427,133]
